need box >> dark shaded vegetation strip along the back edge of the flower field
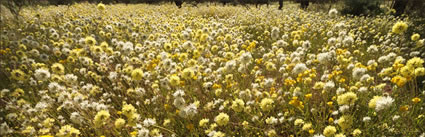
[1,0,425,17]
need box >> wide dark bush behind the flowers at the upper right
[342,0,382,16]
